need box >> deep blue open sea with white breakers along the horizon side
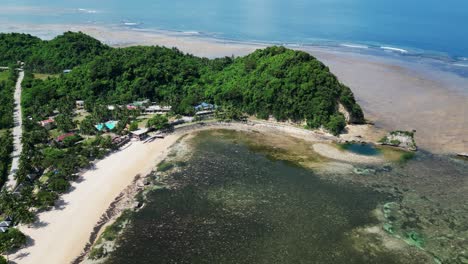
[0,0,468,67]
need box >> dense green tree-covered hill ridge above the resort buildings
[0,32,364,133]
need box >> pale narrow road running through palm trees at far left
[6,69,24,190]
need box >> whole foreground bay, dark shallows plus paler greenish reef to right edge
[100,130,468,263]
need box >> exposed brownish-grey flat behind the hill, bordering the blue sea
[1,24,468,153]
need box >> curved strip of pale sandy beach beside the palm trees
[9,135,178,264]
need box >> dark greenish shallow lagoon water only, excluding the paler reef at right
[104,131,444,263]
